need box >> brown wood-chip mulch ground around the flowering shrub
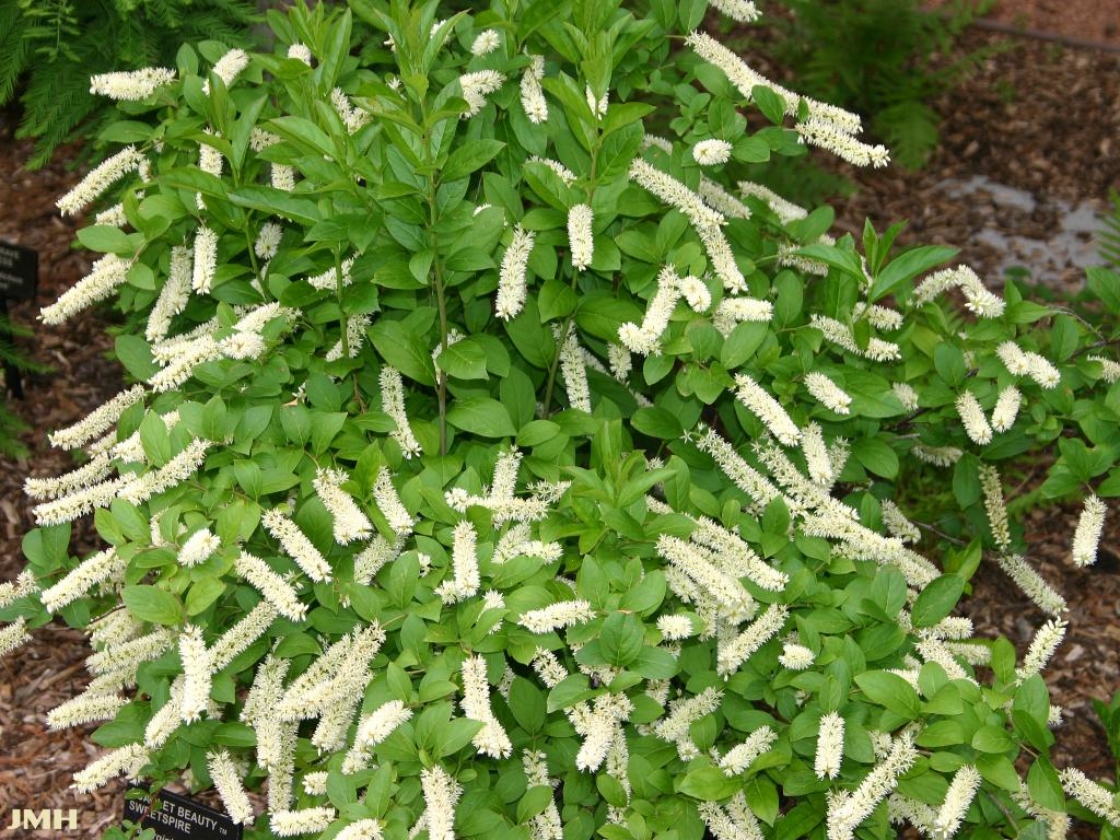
[0,0,1120,838]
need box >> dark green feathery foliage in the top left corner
[0,0,255,169]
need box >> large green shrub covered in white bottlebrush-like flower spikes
[0,0,1120,840]
